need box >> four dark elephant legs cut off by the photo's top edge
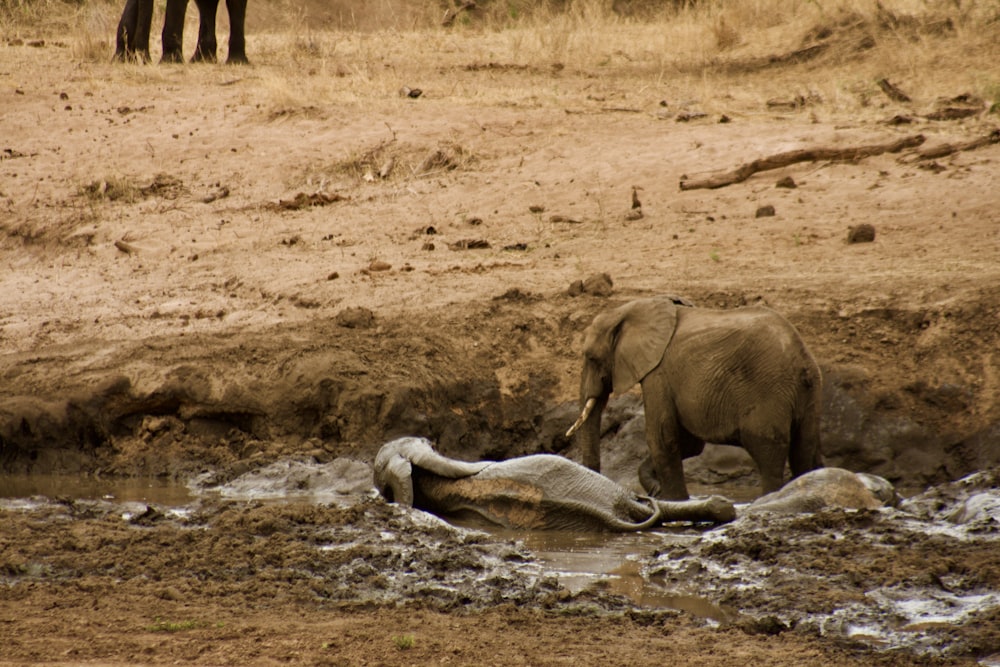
[115,0,248,63]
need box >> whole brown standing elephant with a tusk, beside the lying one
[567,297,822,499]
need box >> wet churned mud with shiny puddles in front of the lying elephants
[0,460,1000,664]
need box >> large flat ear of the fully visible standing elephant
[611,298,677,394]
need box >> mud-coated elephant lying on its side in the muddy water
[374,438,735,532]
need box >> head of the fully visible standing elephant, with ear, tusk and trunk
[566,296,691,471]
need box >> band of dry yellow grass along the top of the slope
[0,0,1000,115]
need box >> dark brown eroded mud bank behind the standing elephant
[0,289,1000,488]
